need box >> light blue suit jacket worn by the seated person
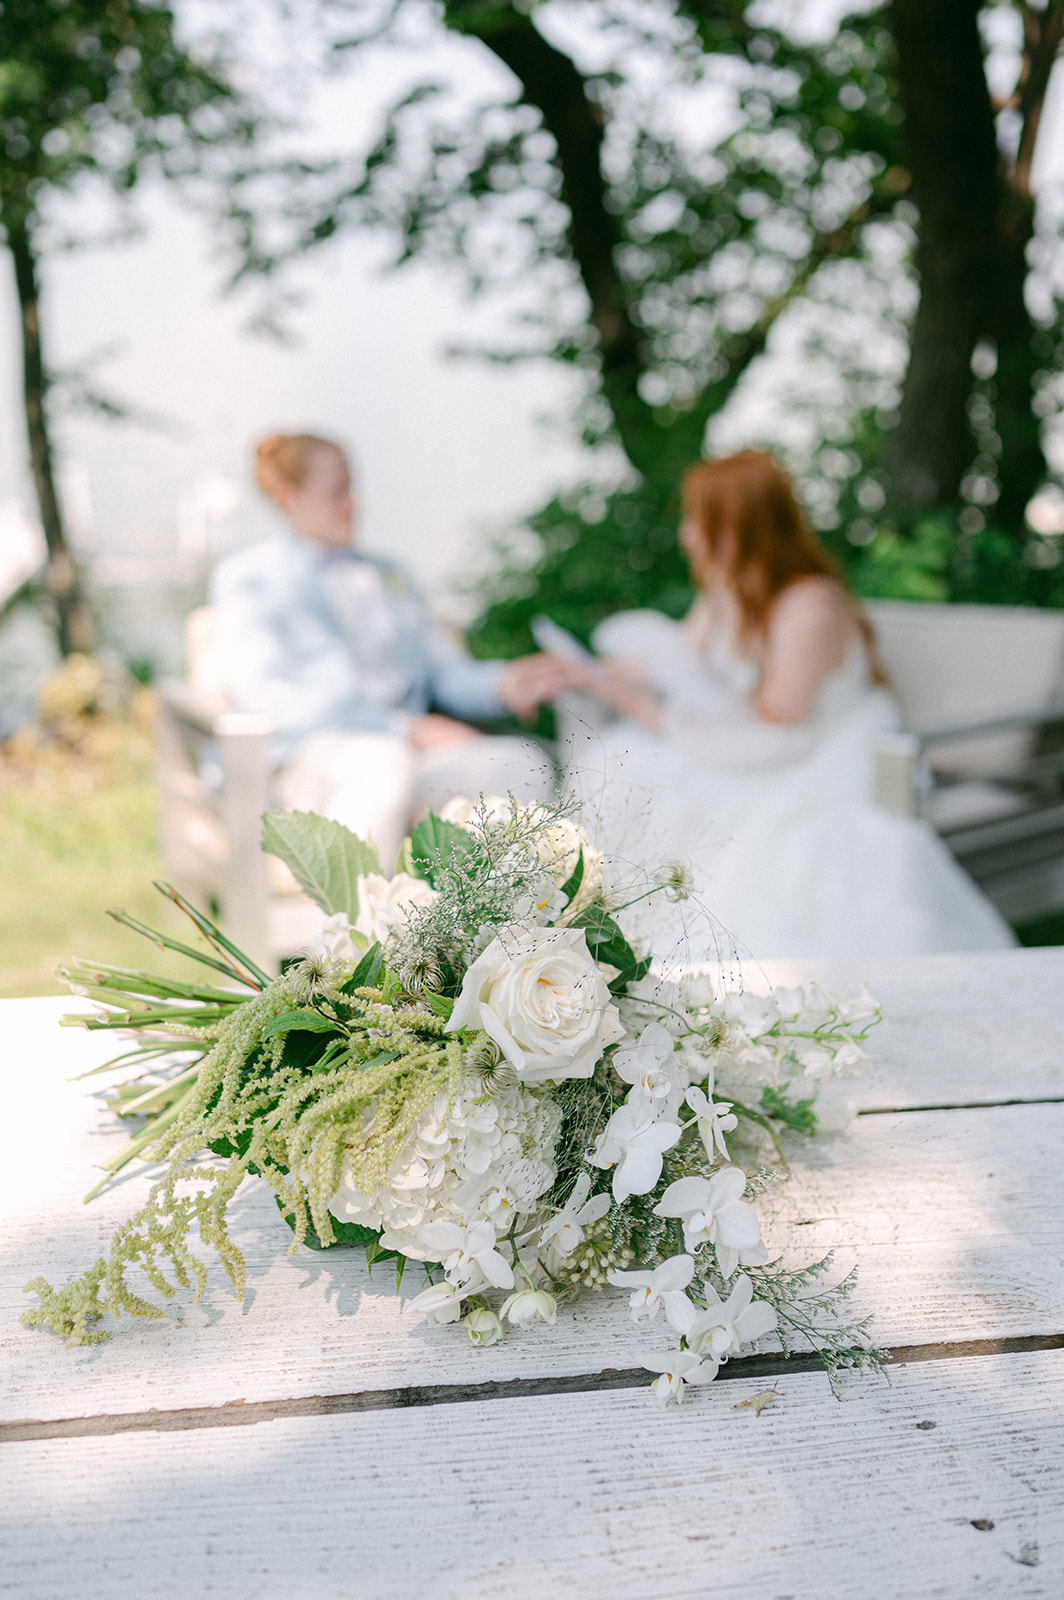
[210,533,506,763]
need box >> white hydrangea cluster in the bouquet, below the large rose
[330,1075,562,1261]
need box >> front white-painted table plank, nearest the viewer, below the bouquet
[0,1354,1064,1600]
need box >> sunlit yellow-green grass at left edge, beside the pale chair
[0,694,216,998]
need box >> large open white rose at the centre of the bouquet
[448,928,624,1083]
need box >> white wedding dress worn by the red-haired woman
[570,611,1016,958]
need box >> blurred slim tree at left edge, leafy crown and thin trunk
[0,0,254,653]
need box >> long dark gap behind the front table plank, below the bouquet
[0,1333,1064,1445]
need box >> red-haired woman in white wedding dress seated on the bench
[570,450,1016,958]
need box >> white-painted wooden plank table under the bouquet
[0,950,1064,1600]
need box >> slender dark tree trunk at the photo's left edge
[6,224,93,656]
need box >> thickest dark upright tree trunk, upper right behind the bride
[888,0,998,515]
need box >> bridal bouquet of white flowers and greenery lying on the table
[24,800,882,1400]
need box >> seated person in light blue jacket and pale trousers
[210,434,568,867]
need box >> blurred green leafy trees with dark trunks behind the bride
[238,0,1064,653]
